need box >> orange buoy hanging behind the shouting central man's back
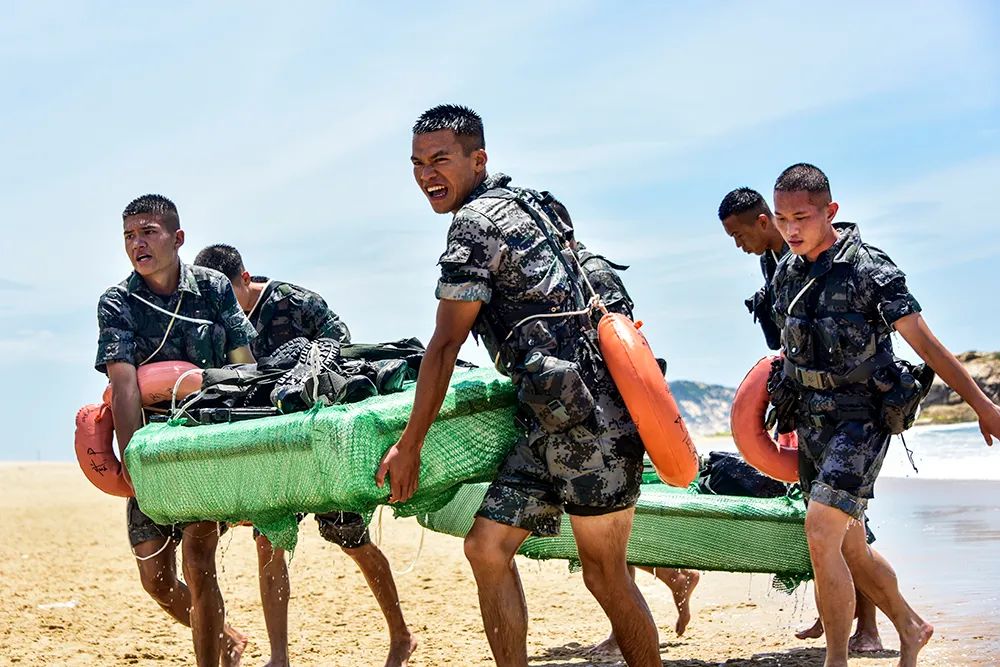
[597,313,698,487]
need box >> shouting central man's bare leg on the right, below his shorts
[570,508,662,667]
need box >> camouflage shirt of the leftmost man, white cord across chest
[94,262,255,373]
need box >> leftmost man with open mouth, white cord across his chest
[95,195,254,667]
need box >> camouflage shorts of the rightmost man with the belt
[798,421,889,520]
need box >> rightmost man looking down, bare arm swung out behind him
[773,163,1000,667]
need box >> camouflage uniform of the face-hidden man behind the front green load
[249,276,371,549]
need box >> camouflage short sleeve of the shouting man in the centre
[434,212,501,303]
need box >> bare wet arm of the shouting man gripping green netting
[375,299,482,502]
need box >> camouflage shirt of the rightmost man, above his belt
[772,223,920,392]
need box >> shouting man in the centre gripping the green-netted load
[376,105,660,667]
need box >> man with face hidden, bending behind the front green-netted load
[194,243,417,667]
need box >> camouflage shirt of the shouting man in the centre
[436,174,582,368]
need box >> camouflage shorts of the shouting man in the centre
[478,420,643,536]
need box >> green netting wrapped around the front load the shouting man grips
[125,369,519,549]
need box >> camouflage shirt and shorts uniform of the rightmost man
[773,223,920,519]
